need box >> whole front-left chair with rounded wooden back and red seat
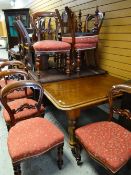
[0,80,64,175]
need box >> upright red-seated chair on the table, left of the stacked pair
[33,12,71,77]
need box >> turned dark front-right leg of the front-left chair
[57,143,64,170]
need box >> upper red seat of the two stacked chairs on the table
[62,35,99,43]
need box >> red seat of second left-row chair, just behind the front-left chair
[3,98,45,123]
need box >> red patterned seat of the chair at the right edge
[75,121,131,173]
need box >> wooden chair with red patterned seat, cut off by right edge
[75,84,131,173]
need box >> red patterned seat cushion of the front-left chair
[8,117,64,162]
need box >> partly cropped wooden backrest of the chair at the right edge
[108,84,131,120]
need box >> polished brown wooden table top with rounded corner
[43,74,124,110]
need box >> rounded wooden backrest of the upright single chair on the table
[32,11,58,41]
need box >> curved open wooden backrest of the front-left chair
[0,80,43,125]
